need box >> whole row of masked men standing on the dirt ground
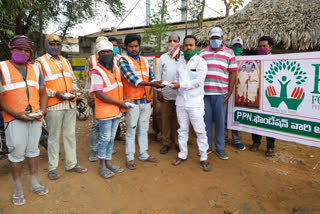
[0,28,274,205]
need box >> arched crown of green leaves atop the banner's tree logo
[264,60,307,85]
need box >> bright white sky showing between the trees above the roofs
[46,0,251,37]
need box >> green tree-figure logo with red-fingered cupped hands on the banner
[264,60,307,110]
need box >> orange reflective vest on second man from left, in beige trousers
[36,54,77,107]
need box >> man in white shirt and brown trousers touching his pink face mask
[156,34,182,154]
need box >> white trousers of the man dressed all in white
[176,106,209,161]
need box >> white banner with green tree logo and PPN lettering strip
[228,52,320,147]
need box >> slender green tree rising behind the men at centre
[142,0,174,54]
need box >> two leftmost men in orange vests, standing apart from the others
[0,34,88,205]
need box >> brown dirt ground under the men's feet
[0,115,320,214]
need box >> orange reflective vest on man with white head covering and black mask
[90,65,123,119]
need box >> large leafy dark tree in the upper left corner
[0,0,125,59]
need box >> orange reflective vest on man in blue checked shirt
[123,55,151,101]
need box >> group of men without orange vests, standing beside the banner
[157,28,275,171]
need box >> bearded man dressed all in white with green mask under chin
[171,35,211,171]
